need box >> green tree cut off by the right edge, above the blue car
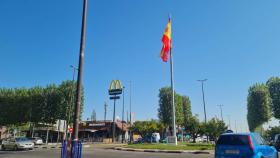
[266,77,280,119]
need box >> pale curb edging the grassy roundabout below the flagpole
[113,147,213,154]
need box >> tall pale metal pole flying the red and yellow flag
[169,17,177,145]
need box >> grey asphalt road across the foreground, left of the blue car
[0,148,214,158]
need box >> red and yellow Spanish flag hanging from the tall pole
[160,18,172,62]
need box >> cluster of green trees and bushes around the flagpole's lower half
[131,87,227,142]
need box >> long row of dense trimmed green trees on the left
[0,80,84,126]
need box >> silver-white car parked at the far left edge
[2,137,34,150]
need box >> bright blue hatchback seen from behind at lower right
[215,133,278,158]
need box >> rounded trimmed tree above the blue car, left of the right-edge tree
[247,84,271,131]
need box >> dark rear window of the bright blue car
[217,135,249,145]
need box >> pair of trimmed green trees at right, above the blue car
[247,77,280,131]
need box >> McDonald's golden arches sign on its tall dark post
[109,80,123,143]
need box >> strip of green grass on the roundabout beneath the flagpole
[124,143,214,150]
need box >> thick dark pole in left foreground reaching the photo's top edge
[72,0,87,144]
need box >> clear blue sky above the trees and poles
[0,0,280,131]
